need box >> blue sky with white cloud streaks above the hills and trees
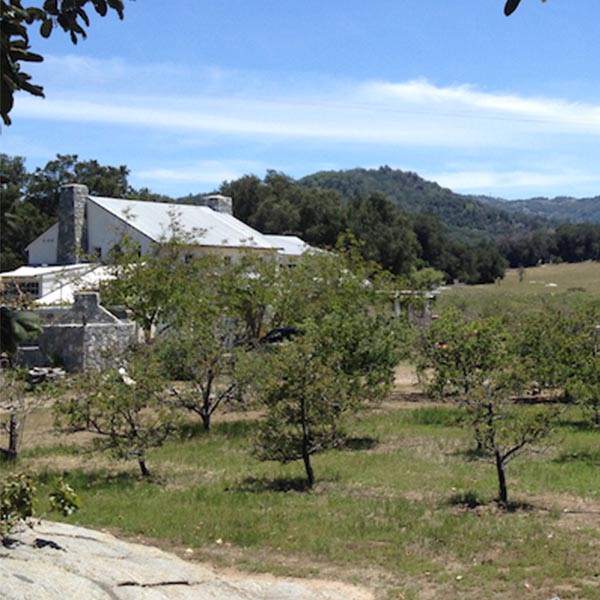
[2,0,600,198]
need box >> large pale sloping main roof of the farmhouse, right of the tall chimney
[88,196,275,250]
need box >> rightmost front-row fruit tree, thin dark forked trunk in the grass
[420,310,558,506]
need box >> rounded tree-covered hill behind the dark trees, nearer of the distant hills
[298,167,546,235]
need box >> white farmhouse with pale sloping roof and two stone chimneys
[1,184,310,303]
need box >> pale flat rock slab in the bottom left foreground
[0,521,371,600]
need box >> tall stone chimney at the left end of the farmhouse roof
[56,183,89,265]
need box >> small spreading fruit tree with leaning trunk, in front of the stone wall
[55,347,179,477]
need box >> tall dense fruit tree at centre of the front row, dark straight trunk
[248,251,403,487]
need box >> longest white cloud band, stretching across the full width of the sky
[15,56,600,148]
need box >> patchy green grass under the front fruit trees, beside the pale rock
[5,404,600,600]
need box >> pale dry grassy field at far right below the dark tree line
[439,261,600,310]
